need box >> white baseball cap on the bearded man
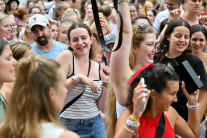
[28,14,49,30]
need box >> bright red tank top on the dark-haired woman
[138,112,175,138]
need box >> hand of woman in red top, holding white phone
[132,82,150,119]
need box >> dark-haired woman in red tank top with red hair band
[115,64,200,138]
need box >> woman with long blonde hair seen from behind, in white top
[0,56,78,138]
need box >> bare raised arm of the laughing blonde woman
[110,2,132,105]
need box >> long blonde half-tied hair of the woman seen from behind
[0,56,64,138]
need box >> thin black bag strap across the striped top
[58,60,91,116]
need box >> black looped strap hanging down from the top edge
[91,0,123,52]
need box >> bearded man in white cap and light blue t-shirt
[28,14,68,59]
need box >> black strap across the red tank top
[155,112,165,138]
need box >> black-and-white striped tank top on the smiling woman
[60,80,102,119]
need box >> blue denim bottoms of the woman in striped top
[59,114,106,138]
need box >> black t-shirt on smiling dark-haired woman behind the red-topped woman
[154,55,207,121]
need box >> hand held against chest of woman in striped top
[79,74,99,92]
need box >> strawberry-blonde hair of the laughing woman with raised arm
[129,25,155,70]
